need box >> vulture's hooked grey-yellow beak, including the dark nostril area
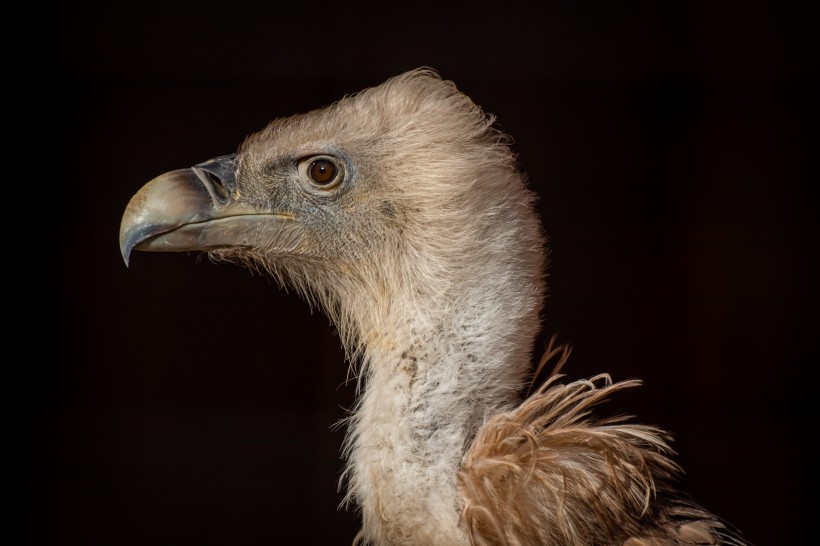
[120,155,301,265]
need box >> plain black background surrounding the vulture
[24,1,818,545]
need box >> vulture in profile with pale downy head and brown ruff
[119,67,748,546]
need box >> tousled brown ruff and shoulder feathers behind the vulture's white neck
[459,344,746,546]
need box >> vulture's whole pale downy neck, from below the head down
[339,198,543,544]
